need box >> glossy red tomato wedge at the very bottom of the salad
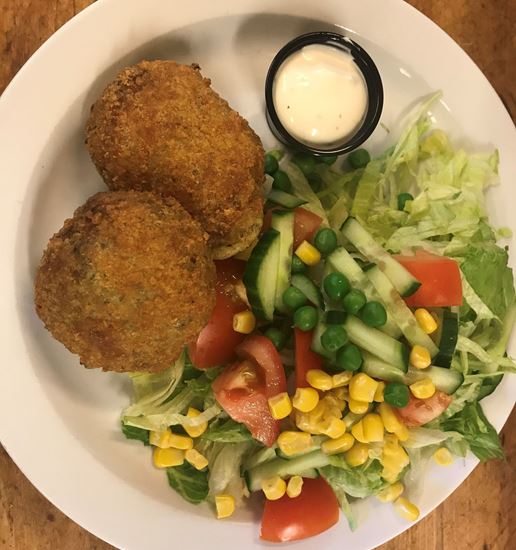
[260,477,339,542]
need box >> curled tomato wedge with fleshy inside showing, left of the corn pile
[212,334,287,447]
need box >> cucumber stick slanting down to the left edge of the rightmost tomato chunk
[342,218,421,298]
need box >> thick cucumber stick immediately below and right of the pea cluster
[342,315,409,372]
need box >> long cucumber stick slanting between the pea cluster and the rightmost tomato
[365,265,439,357]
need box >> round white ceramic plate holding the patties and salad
[0,0,516,550]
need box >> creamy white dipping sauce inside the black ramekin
[273,44,368,145]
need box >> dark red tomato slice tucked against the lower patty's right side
[189,259,247,369]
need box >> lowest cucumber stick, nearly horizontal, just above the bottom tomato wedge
[244,451,330,492]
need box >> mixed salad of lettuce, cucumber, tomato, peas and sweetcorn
[122,94,516,541]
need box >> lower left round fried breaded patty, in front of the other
[35,191,215,372]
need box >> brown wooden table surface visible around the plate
[0,0,516,550]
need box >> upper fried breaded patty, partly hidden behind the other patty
[86,61,264,259]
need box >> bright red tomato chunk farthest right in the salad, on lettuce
[396,251,462,307]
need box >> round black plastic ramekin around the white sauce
[265,31,383,156]
